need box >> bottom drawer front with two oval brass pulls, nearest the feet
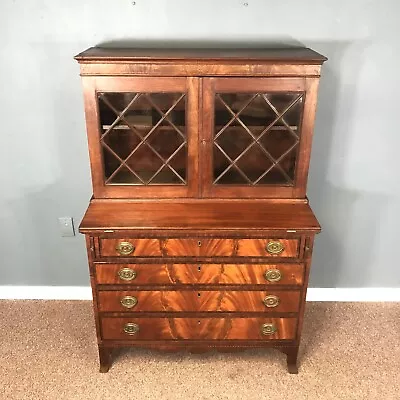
[101,317,297,341]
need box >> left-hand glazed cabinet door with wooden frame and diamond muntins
[83,77,198,197]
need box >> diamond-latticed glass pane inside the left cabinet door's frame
[98,92,187,185]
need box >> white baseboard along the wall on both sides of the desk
[0,286,400,302]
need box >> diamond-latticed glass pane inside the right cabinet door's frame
[213,93,303,186]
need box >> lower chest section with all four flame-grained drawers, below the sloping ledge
[87,236,316,374]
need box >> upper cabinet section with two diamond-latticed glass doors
[77,49,324,198]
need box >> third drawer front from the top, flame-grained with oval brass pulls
[98,290,300,312]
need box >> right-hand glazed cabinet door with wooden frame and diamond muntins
[202,78,314,198]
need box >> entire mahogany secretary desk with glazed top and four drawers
[75,48,326,373]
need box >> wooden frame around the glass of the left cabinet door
[82,76,200,199]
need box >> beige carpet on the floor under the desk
[0,301,400,400]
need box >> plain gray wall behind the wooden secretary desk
[0,0,400,287]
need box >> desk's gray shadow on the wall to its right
[307,41,387,287]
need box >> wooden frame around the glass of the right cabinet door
[199,77,319,198]
